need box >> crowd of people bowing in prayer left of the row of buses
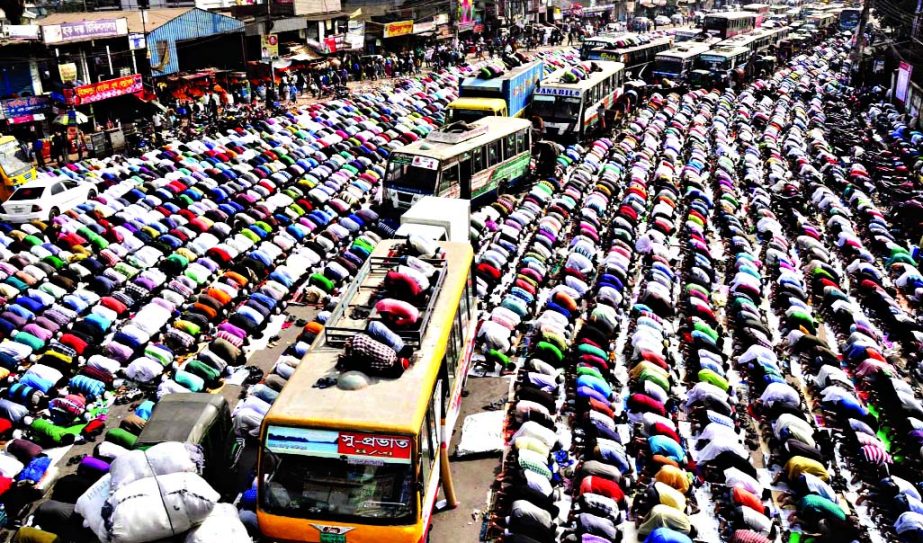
[0,47,470,543]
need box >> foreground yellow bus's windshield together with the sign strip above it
[259,426,417,525]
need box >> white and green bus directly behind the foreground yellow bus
[383,117,532,211]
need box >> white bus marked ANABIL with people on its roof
[532,60,625,141]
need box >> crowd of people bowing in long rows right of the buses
[473,30,923,543]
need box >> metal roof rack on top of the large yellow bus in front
[324,250,448,349]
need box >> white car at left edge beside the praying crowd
[0,179,96,222]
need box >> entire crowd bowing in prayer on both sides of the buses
[0,12,923,543]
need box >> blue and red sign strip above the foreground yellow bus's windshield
[266,426,413,464]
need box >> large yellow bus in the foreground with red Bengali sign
[257,240,477,543]
